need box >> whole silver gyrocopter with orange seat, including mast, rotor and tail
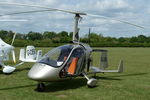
[0,3,143,91]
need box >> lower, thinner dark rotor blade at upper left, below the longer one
[0,10,54,17]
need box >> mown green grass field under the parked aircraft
[0,48,150,100]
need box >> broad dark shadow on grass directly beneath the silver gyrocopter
[35,78,87,92]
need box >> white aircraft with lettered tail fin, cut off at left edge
[0,33,42,74]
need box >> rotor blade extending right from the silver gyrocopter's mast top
[87,14,145,29]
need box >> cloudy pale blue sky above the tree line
[0,0,150,37]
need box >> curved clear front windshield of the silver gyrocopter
[39,45,73,67]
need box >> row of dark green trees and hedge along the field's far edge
[0,30,150,47]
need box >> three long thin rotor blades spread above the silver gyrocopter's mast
[0,2,144,29]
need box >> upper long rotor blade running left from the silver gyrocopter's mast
[0,2,86,15]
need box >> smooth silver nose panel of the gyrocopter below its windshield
[28,63,62,82]
